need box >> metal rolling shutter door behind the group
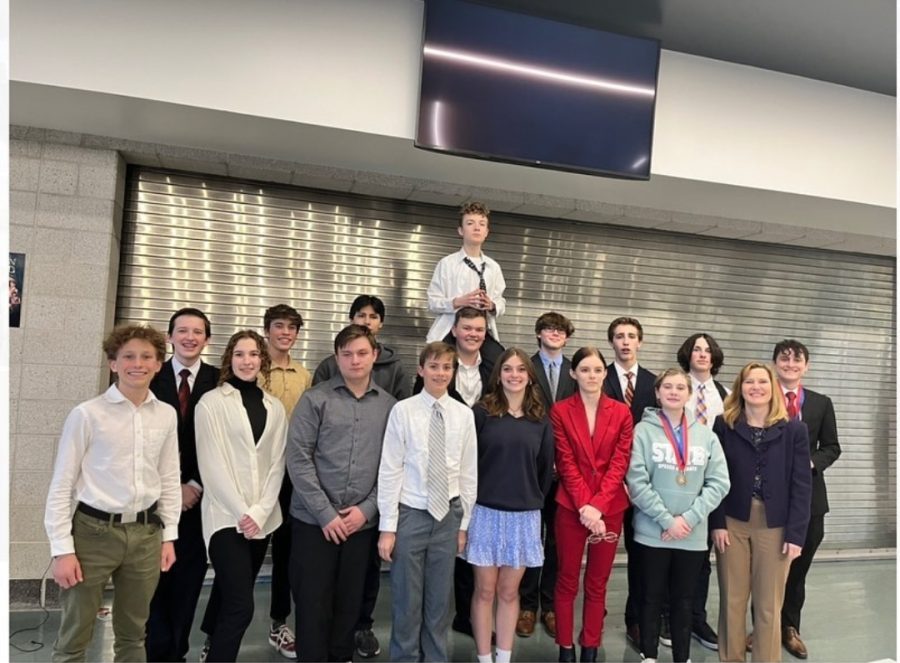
[116,168,896,549]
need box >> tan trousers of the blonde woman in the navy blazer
[716,499,790,661]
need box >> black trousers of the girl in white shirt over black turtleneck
[202,527,269,663]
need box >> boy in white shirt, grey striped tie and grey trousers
[378,341,478,661]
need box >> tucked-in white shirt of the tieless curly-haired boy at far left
[44,385,181,557]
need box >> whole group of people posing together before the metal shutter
[45,203,840,662]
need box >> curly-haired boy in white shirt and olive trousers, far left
[44,325,181,661]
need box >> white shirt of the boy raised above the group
[425,249,506,343]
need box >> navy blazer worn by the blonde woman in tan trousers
[709,415,812,546]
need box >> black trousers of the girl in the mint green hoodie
[634,542,706,661]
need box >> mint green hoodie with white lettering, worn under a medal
[625,407,731,550]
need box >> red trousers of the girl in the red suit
[555,505,624,647]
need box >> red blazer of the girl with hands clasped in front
[550,392,634,514]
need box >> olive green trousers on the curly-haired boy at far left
[53,512,162,662]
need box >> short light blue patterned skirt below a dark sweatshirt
[462,504,544,568]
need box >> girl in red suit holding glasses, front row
[550,347,633,661]
